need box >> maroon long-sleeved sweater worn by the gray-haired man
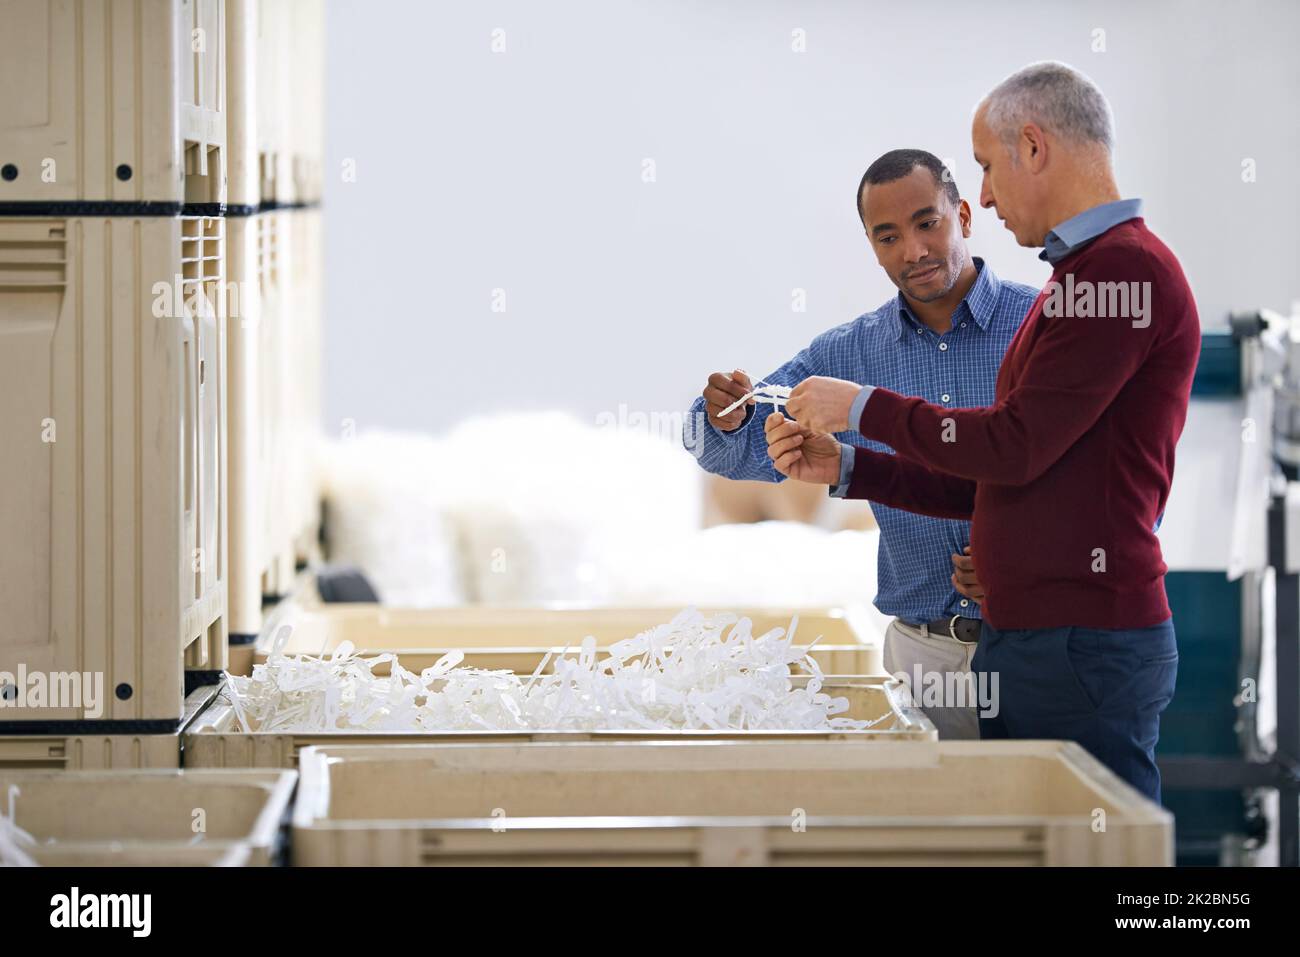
[848,218,1200,629]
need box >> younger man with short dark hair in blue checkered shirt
[683,150,1039,739]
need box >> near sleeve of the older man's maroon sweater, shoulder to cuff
[858,250,1161,486]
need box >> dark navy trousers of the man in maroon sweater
[971,618,1178,802]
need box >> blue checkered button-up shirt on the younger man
[683,259,1039,624]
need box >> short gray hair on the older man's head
[980,60,1115,152]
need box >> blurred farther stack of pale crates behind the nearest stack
[226,0,324,671]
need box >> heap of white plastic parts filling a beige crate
[228,609,888,732]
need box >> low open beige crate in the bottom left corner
[0,770,298,867]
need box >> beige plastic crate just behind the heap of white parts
[255,594,884,676]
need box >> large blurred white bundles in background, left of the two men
[315,412,703,607]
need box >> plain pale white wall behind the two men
[325,0,1300,433]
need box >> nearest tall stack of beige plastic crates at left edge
[0,0,228,767]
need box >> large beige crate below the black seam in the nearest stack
[0,217,226,722]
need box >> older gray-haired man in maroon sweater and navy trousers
[767,62,1200,801]
